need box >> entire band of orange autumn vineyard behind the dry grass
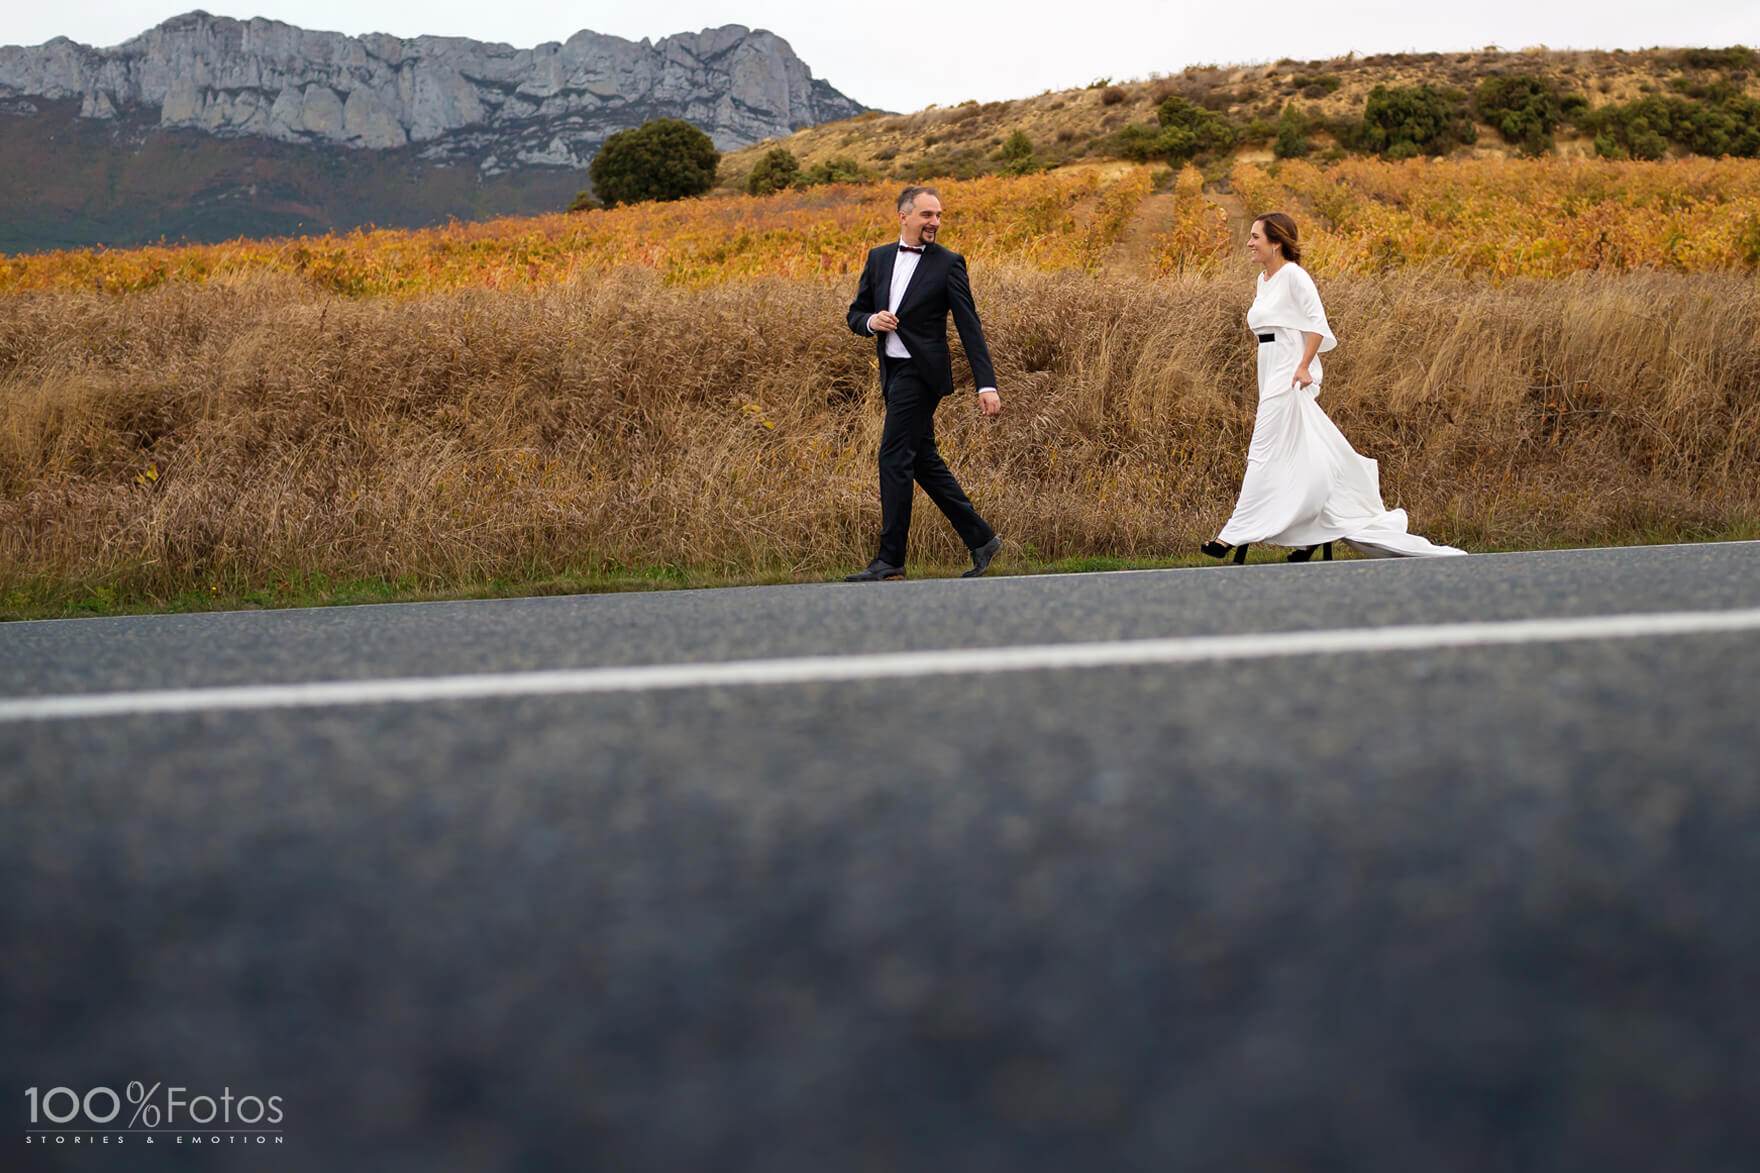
[0,159,1760,294]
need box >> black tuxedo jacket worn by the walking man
[848,241,996,395]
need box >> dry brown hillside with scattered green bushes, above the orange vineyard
[722,46,1760,190]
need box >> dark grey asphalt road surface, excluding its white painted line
[0,542,1760,1173]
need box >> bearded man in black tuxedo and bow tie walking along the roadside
[845,187,1001,583]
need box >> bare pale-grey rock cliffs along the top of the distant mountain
[0,11,862,176]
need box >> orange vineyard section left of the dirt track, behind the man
[0,167,1151,294]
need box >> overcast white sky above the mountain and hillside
[10,0,1760,111]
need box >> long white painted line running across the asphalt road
[0,608,1760,722]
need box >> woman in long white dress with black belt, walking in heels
[1202,211,1466,562]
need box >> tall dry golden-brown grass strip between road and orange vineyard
[0,262,1760,597]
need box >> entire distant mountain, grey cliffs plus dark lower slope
[0,12,862,252]
